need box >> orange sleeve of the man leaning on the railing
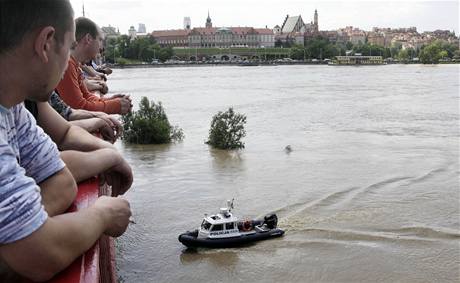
[56,60,121,114]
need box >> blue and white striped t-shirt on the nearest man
[0,103,64,244]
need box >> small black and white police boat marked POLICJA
[179,200,284,248]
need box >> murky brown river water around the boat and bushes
[109,65,460,282]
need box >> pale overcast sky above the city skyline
[70,0,460,35]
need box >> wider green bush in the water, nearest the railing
[122,97,184,144]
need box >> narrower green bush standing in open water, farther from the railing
[206,107,246,149]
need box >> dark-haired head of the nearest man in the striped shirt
[0,0,75,101]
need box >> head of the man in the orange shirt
[75,17,103,63]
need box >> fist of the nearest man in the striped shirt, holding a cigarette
[93,196,131,237]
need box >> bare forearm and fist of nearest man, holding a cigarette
[0,196,131,281]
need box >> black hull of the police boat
[179,228,284,248]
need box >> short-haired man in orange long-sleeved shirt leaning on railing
[56,18,132,114]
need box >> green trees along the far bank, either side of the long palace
[104,35,460,64]
